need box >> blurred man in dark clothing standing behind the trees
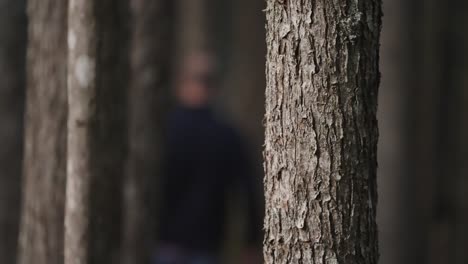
[154,53,261,264]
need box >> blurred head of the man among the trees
[176,52,217,108]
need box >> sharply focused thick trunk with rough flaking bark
[264,0,381,264]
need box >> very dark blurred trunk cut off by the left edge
[0,0,27,263]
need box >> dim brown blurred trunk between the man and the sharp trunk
[224,0,266,146]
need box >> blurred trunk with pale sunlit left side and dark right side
[65,0,128,264]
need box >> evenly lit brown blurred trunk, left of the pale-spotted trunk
[18,0,67,264]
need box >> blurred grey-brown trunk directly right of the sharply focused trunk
[377,0,413,264]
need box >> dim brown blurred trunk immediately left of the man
[122,0,171,264]
